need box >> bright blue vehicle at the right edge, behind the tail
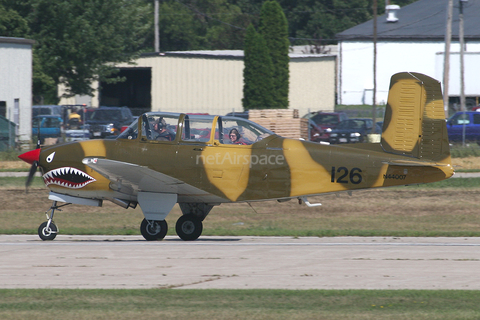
[447,111,480,145]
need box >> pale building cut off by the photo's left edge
[0,37,35,145]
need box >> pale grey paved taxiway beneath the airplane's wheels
[0,235,480,290]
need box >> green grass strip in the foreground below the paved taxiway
[0,289,480,320]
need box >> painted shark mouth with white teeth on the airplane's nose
[43,167,96,189]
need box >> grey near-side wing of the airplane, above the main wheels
[82,158,228,203]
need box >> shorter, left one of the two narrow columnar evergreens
[242,25,274,110]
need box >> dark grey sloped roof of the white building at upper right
[336,0,480,41]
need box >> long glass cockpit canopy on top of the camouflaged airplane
[117,112,274,145]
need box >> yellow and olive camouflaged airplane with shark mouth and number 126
[19,72,454,241]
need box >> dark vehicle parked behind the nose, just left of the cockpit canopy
[86,107,133,139]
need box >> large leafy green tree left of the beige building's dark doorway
[29,0,151,96]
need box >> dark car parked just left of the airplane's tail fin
[330,118,382,144]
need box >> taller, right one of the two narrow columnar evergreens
[259,0,290,109]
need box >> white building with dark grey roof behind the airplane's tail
[337,0,480,110]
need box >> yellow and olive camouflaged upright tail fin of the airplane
[381,72,451,163]
